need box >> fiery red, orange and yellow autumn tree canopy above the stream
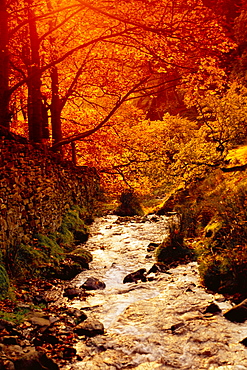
[0,0,247,194]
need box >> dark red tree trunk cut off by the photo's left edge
[0,0,11,130]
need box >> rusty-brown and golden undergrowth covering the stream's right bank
[168,170,247,296]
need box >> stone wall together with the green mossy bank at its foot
[0,137,100,297]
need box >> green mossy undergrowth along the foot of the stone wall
[0,206,92,299]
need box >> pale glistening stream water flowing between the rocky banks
[64,216,247,370]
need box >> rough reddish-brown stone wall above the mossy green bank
[0,137,99,253]
